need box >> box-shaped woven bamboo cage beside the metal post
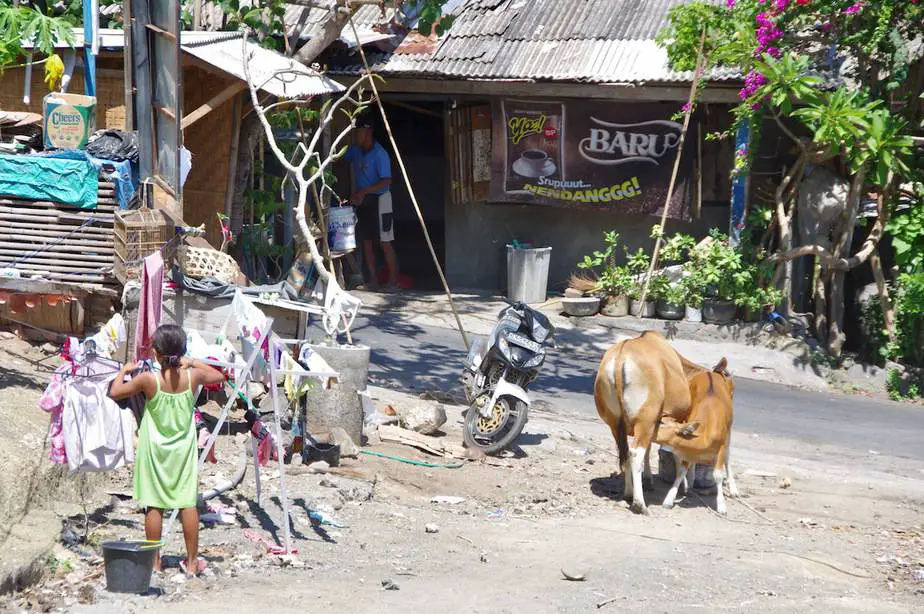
[113,209,176,284]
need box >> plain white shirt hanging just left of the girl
[62,360,135,472]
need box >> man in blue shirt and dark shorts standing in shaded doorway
[344,121,398,289]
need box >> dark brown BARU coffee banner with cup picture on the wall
[490,99,696,218]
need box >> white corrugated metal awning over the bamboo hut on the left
[23,28,346,98]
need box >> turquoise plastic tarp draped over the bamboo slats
[0,151,99,209]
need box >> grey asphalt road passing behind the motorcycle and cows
[353,313,924,460]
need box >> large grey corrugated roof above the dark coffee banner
[329,0,740,83]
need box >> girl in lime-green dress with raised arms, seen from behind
[109,324,224,574]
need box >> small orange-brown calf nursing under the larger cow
[655,358,738,515]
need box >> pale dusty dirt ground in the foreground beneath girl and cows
[0,340,924,614]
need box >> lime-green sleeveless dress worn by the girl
[135,371,199,509]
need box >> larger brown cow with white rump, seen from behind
[594,330,706,514]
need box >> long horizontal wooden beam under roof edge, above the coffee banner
[333,77,740,104]
